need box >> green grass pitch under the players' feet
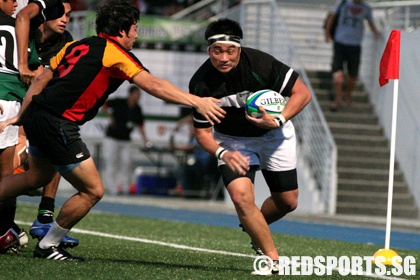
[0,202,420,280]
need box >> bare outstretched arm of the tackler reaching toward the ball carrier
[133,71,226,124]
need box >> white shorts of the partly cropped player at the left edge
[0,100,20,149]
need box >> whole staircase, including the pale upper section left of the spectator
[279,1,419,218]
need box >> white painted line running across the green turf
[16,221,404,280]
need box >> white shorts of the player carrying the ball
[214,121,297,171]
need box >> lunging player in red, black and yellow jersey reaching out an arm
[0,0,225,261]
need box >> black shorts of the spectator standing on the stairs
[332,42,361,78]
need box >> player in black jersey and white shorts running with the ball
[189,19,311,274]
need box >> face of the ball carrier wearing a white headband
[208,43,241,73]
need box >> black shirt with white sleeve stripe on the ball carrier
[189,47,298,137]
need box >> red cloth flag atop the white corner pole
[379,30,401,87]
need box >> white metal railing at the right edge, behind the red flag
[360,1,420,209]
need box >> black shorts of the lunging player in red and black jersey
[23,104,90,165]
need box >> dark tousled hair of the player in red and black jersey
[96,0,140,36]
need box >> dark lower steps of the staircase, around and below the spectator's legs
[308,71,418,218]
